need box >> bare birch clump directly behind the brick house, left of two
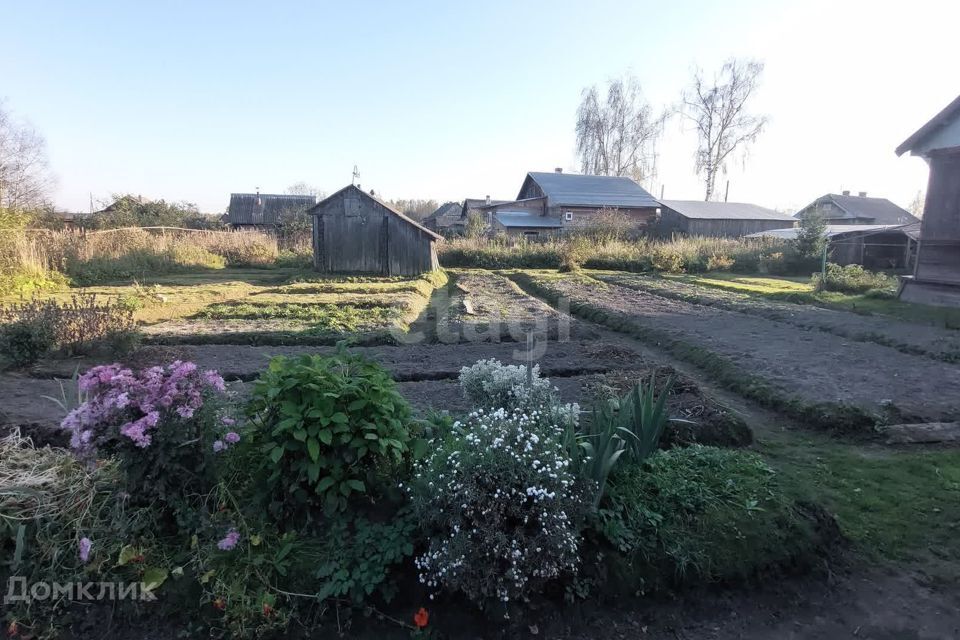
[575,75,667,182]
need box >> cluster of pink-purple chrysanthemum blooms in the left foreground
[61,360,226,454]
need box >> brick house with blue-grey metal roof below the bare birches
[481,169,660,236]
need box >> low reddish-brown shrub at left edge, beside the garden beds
[0,294,139,355]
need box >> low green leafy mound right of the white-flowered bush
[599,445,822,589]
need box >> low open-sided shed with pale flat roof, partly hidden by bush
[747,222,920,269]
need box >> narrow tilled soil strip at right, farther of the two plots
[595,273,960,362]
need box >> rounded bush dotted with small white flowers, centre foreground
[408,408,583,603]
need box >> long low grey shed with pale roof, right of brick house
[658,200,797,238]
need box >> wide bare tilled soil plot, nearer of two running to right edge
[518,273,960,420]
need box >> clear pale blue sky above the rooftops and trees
[0,0,960,212]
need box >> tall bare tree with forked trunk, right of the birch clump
[683,58,767,201]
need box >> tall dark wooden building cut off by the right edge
[897,92,960,306]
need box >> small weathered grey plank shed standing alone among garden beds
[310,185,443,276]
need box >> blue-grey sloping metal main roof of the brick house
[517,171,660,208]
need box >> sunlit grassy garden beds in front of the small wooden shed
[0,268,447,344]
